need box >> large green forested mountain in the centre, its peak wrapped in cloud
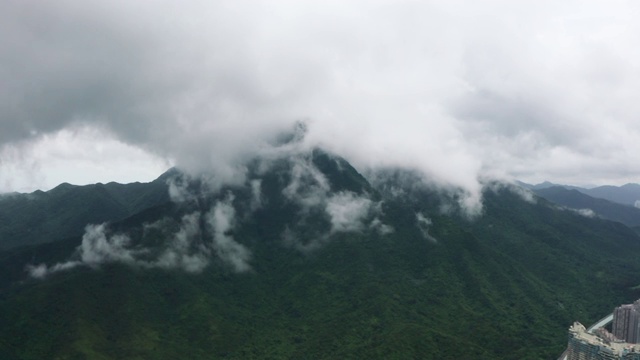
[0,151,640,360]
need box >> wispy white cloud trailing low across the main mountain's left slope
[26,194,251,278]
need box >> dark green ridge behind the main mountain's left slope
[0,177,169,249]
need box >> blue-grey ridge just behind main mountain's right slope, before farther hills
[534,186,640,227]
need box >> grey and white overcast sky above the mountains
[0,0,640,195]
